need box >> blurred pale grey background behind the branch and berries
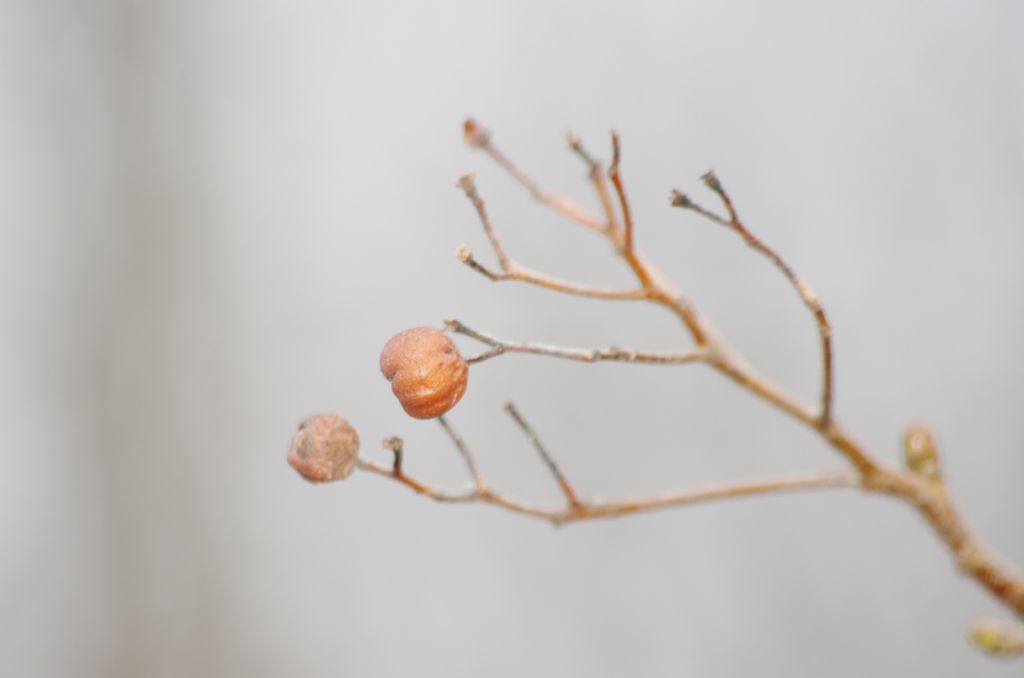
[0,0,1024,677]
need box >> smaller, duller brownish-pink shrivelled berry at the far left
[288,415,359,482]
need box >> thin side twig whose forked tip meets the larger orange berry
[444,319,711,365]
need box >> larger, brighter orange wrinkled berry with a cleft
[381,328,469,419]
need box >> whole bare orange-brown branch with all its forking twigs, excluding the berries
[350,120,1024,651]
